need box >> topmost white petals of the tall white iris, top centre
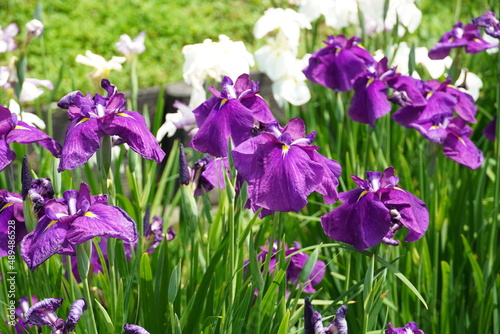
[253,8,312,46]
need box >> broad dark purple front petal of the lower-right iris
[321,189,391,250]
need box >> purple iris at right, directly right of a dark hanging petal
[391,76,477,127]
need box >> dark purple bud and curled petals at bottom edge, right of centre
[304,297,347,334]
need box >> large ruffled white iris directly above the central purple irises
[182,35,254,108]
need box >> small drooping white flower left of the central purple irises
[156,100,198,142]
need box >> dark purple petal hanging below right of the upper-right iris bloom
[347,77,391,127]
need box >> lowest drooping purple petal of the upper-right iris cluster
[443,133,484,169]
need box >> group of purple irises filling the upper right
[303,12,500,169]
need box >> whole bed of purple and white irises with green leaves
[0,0,500,334]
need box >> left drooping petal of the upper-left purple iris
[57,118,101,172]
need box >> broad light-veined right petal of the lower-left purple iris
[66,203,137,245]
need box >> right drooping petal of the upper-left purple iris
[103,111,166,163]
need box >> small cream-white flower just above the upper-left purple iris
[75,50,127,90]
